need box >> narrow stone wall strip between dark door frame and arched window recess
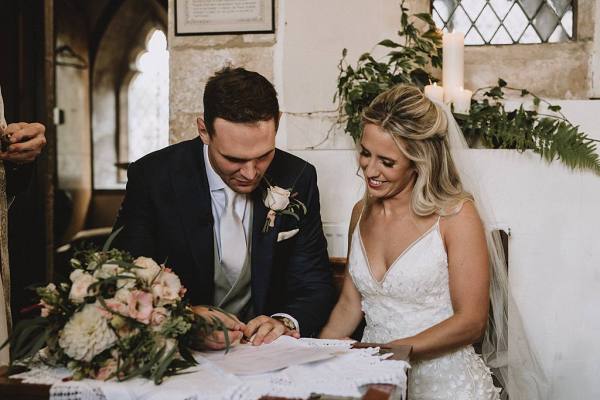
[54,0,92,245]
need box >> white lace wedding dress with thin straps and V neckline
[348,218,500,400]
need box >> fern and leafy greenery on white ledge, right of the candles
[455,79,600,175]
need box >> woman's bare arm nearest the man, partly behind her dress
[319,201,363,339]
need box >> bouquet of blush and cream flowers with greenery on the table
[3,231,227,384]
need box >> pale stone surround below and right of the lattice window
[465,0,600,99]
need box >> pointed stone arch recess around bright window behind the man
[92,0,168,191]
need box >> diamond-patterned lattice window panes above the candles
[431,0,574,45]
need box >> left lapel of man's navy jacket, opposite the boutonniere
[171,139,214,302]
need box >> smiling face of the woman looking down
[359,124,415,199]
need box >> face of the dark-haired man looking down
[197,118,276,194]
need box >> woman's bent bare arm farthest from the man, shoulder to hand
[391,202,489,360]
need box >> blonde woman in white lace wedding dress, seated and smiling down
[321,85,500,400]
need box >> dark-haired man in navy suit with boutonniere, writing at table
[115,68,334,349]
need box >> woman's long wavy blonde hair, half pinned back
[362,85,473,216]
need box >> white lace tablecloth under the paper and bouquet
[11,339,410,400]
